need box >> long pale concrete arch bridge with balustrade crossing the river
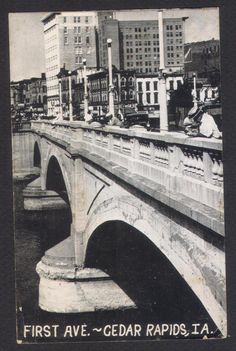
[14,121,226,335]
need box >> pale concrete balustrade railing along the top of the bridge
[32,121,223,212]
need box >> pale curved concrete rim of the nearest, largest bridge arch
[86,197,226,333]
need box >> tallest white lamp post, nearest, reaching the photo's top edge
[158,11,168,132]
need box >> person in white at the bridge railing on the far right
[184,105,222,139]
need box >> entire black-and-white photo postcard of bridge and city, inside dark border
[8,7,228,344]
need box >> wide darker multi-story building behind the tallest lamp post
[98,17,187,73]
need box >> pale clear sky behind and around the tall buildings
[9,8,219,81]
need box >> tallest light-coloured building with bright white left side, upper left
[42,11,111,115]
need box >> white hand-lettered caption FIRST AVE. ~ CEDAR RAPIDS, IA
[24,323,213,338]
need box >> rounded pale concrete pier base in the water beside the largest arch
[36,236,136,313]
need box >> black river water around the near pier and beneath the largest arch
[14,181,220,342]
